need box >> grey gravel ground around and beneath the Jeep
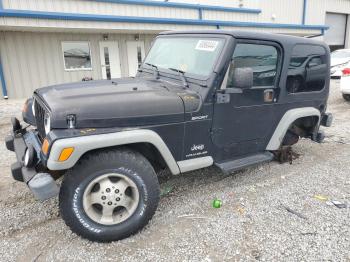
[0,81,350,261]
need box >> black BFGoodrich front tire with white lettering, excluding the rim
[59,148,160,242]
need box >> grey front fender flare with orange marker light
[47,129,180,175]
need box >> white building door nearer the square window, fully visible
[100,41,121,79]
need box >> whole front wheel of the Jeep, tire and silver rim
[59,149,160,242]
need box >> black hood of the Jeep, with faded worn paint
[35,78,201,128]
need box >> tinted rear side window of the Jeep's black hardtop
[286,45,329,93]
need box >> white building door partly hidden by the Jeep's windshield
[126,41,145,76]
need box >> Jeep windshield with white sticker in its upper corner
[145,37,224,77]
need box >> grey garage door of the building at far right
[324,13,347,51]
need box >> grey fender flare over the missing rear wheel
[266,107,321,151]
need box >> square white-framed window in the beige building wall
[62,41,92,71]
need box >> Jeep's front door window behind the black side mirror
[227,43,278,87]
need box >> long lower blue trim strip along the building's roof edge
[0,9,329,30]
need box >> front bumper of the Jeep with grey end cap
[5,118,59,200]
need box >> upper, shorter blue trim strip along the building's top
[89,0,261,14]
